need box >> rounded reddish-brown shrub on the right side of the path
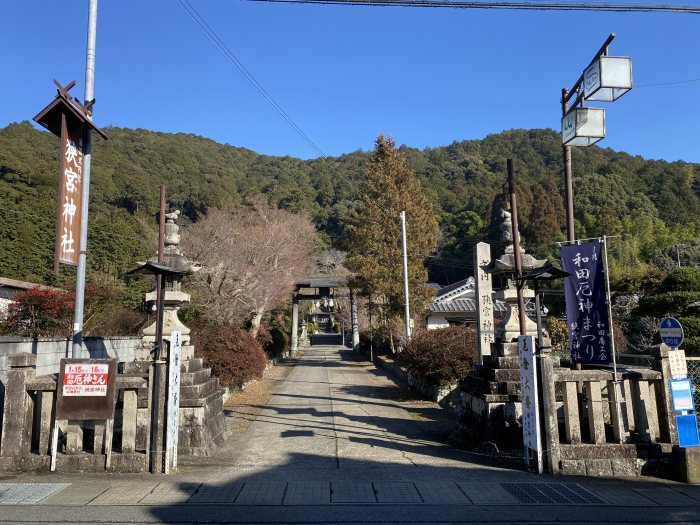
[400,326,478,386]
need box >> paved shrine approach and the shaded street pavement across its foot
[0,347,700,524]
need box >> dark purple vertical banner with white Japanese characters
[561,241,612,365]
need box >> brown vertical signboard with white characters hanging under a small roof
[55,115,83,266]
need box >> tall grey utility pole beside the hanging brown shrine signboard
[71,0,97,358]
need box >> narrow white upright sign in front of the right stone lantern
[518,335,543,473]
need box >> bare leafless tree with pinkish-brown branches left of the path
[183,201,316,335]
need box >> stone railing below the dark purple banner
[541,347,677,472]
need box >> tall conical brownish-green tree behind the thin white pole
[345,135,438,338]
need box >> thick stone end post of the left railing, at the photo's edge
[0,353,36,461]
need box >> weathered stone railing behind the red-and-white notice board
[0,354,150,471]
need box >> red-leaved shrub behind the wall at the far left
[0,287,73,337]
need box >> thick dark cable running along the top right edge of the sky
[242,0,700,15]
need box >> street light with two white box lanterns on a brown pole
[561,33,632,242]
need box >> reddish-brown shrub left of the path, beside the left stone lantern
[190,323,267,387]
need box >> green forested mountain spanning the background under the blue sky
[0,122,700,288]
